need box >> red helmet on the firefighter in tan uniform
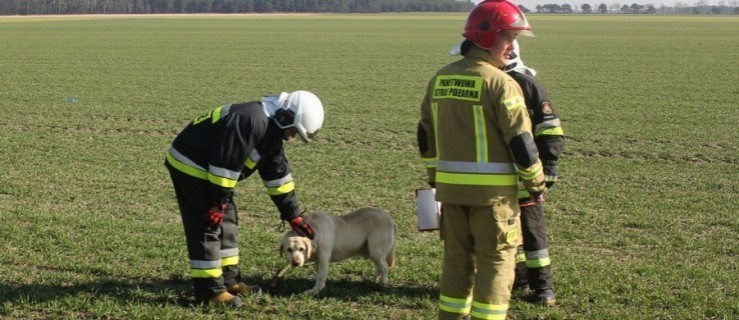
[462,0,534,49]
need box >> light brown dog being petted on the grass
[272,208,397,295]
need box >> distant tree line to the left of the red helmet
[0,0,474,15]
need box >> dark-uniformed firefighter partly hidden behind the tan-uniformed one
[503,38,565,306]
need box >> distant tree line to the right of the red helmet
[518,0,739,14]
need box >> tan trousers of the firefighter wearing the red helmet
[439,195,521,320]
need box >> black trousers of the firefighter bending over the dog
[165,163,241,301]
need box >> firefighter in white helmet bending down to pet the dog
[165,91,323,308]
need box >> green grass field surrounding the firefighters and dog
[0,14,739,319]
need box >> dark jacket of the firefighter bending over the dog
[166,101,299,220]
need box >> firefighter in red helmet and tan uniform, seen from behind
[418,0,545,320]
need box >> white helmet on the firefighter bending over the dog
[262,90,323,142]
